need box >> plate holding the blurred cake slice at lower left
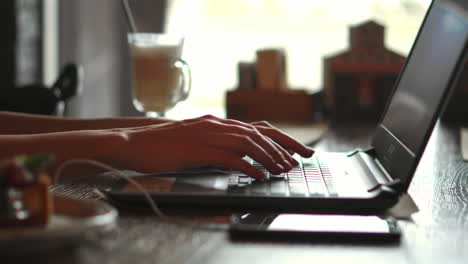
[0,196,118,255]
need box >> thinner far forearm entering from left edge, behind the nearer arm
[0,112,170,135]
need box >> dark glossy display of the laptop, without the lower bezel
[383,1,468,155]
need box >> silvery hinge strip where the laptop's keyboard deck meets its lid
[348,148,403,193]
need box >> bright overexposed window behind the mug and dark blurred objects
[167,0,430,116]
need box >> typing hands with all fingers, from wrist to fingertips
[107,116,314,179]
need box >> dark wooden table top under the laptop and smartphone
[7,120,468,264]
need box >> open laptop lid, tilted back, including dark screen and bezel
[372,0,468,192]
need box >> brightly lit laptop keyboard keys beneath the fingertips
[228,156,336,197]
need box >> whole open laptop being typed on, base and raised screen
[107,0,468,212]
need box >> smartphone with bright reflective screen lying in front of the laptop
[229,213,401,243]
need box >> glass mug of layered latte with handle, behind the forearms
[128,33,191,117]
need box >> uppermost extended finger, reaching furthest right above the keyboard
[249,121,314,157]
